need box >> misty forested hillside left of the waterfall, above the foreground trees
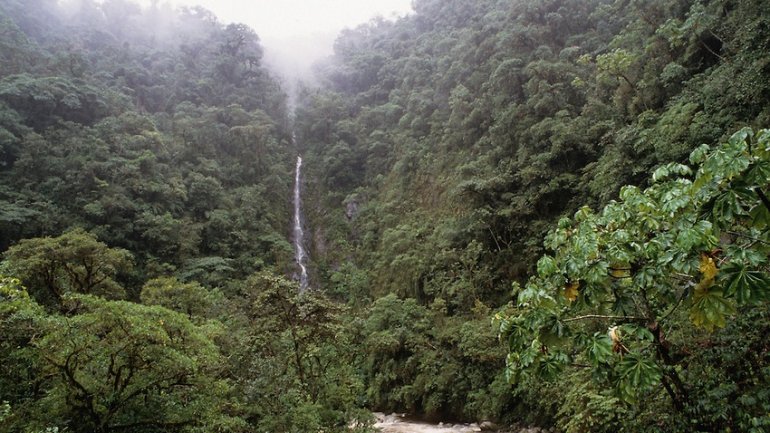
[0,0,294,284]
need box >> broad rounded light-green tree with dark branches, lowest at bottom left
[34,296,228,432]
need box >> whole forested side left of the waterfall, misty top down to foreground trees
[0,0,366,433]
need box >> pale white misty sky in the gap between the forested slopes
[133,0,412,81]
